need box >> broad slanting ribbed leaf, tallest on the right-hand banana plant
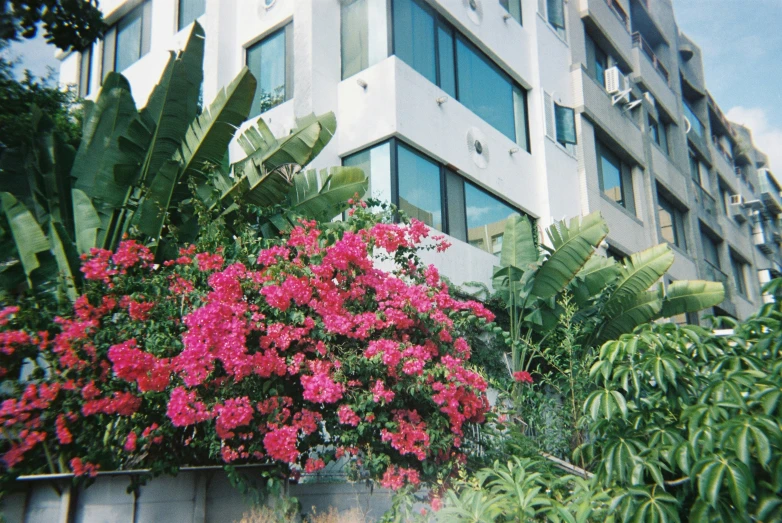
[532,212,608,299]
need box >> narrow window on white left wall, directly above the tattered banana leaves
[247,24,293,117]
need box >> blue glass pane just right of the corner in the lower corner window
[397,145,443,231]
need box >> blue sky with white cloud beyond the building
[1,0,782,168]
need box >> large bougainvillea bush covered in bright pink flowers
[0,207,493,489]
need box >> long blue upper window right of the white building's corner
[393,0,529,151]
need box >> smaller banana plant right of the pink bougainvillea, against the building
[493,213,724,378]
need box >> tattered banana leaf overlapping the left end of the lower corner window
[289,167,369,221]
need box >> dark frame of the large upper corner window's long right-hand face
[388,0,532,153]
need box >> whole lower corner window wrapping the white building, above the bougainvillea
[342,139,520,254]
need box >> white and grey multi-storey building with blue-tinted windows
[60,0,782,320]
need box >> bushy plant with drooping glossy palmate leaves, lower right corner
[578,279,782,522]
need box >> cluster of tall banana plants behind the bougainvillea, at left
[0,22,367,300]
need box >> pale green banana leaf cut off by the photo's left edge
[0,193,49,286]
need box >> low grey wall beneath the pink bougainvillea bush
[0,470,391,523]
